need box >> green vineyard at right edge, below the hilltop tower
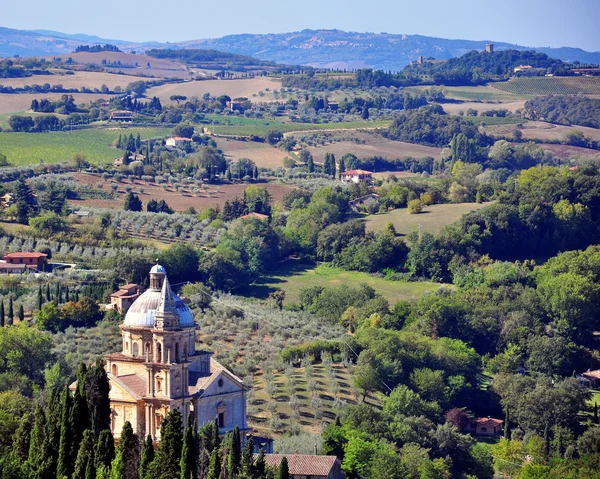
[491,77,600,95]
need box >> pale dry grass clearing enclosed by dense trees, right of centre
[366,203,489,235]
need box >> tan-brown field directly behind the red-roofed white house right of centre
[308,133,442,163]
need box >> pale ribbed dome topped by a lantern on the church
[123,264,196,328]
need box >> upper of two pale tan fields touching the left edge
[0,71,152,91]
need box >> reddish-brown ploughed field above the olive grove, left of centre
[68,173,292,211]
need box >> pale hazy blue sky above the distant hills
[0,0,600,51]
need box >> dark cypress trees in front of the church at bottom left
[0,360,289,479]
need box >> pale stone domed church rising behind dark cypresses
[105,264,248,441]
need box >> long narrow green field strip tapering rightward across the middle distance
[204,115,391,136]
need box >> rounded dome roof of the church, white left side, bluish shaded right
[123,264,196,328]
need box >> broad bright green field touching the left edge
[0,128,171,165]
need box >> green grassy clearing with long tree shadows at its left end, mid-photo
[252,263,441,304]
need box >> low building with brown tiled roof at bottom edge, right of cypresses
[254,454,346,479]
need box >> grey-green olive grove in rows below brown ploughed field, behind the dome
[112,211,226,247]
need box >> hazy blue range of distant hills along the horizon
[0,27,600,71]
